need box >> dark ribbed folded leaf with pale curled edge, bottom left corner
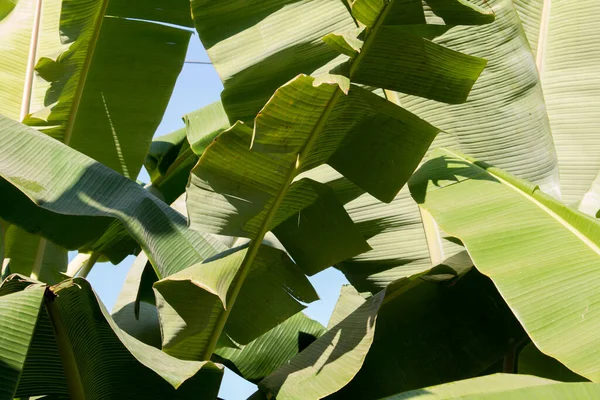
[0,275,222,399]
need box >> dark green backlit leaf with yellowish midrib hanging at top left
[25,0,189,179]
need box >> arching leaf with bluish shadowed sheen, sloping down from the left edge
[0,117,227,277]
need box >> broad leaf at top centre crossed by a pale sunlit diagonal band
[192,0,356,123]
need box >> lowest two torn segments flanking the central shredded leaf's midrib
[154,245,318,359]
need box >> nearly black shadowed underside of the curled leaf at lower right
[333,270,526,399]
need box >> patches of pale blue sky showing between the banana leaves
[83,34,347,400]
